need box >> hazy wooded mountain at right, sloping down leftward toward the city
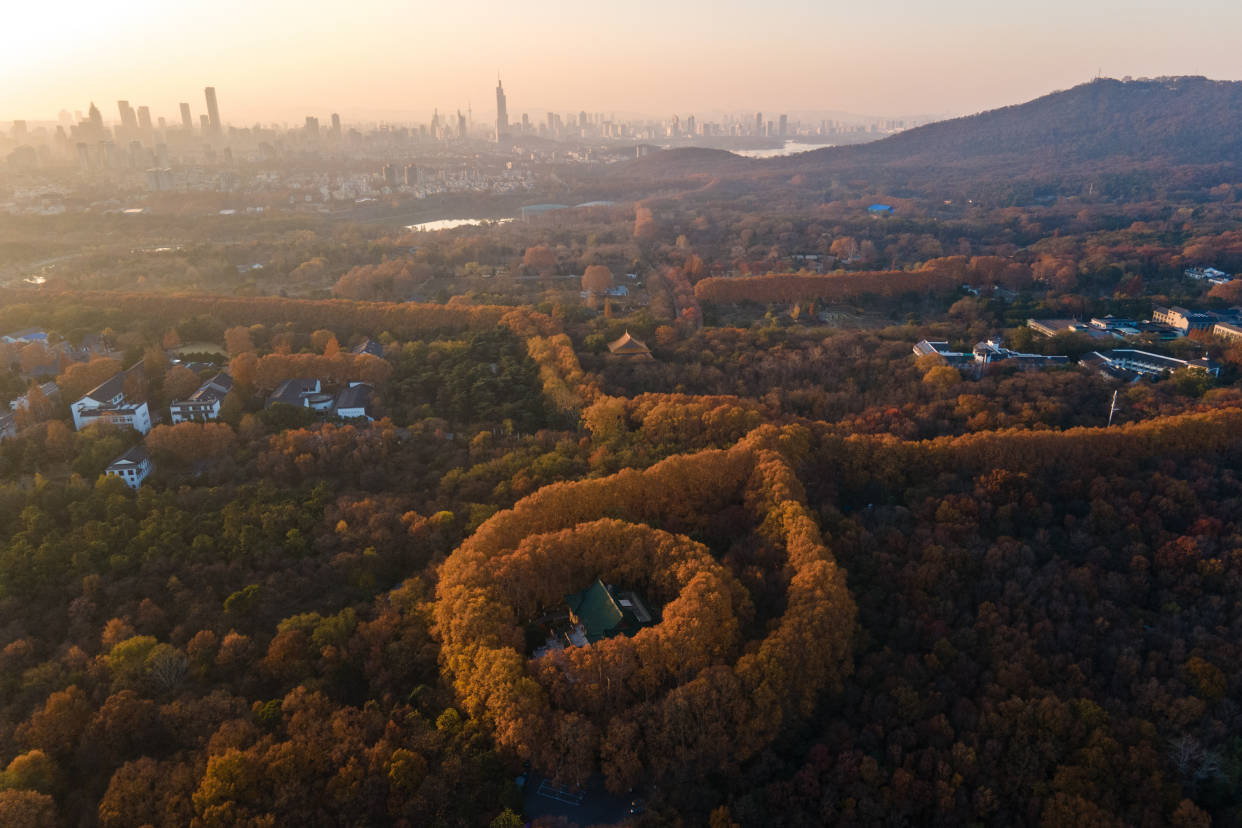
[613,76,1242,204]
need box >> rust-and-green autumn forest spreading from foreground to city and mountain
[0,74,1242,828]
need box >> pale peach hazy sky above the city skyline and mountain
[0,0,1242,125]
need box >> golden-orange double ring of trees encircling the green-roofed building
[436,426,854,791]
